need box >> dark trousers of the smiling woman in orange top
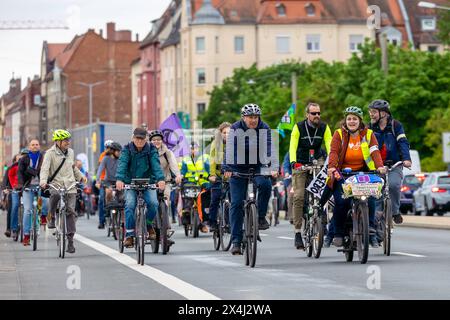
[332,179,376,237]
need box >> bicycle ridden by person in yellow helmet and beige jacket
[49,182,79,259]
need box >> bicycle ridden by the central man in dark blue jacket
[232,169,270,268]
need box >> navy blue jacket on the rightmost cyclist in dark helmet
[369,117,411,163]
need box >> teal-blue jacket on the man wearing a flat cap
[116,142,164,184]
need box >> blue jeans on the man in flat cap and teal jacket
[125,190,158,237]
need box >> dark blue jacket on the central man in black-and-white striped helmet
[222,119,279,173]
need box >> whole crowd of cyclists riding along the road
[2,100,411,262]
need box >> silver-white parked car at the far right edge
[413,171,450,216]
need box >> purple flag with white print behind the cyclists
[159,113,190,157]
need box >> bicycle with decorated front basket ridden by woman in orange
[338,168,383,264]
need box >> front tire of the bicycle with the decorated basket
[353,202,369,264]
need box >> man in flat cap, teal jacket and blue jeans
[116,128,166,248]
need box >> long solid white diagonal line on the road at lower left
[75,234,220,300]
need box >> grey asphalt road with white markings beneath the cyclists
[0,213,450,300]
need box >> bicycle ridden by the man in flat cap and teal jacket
[125,178,157,266]
